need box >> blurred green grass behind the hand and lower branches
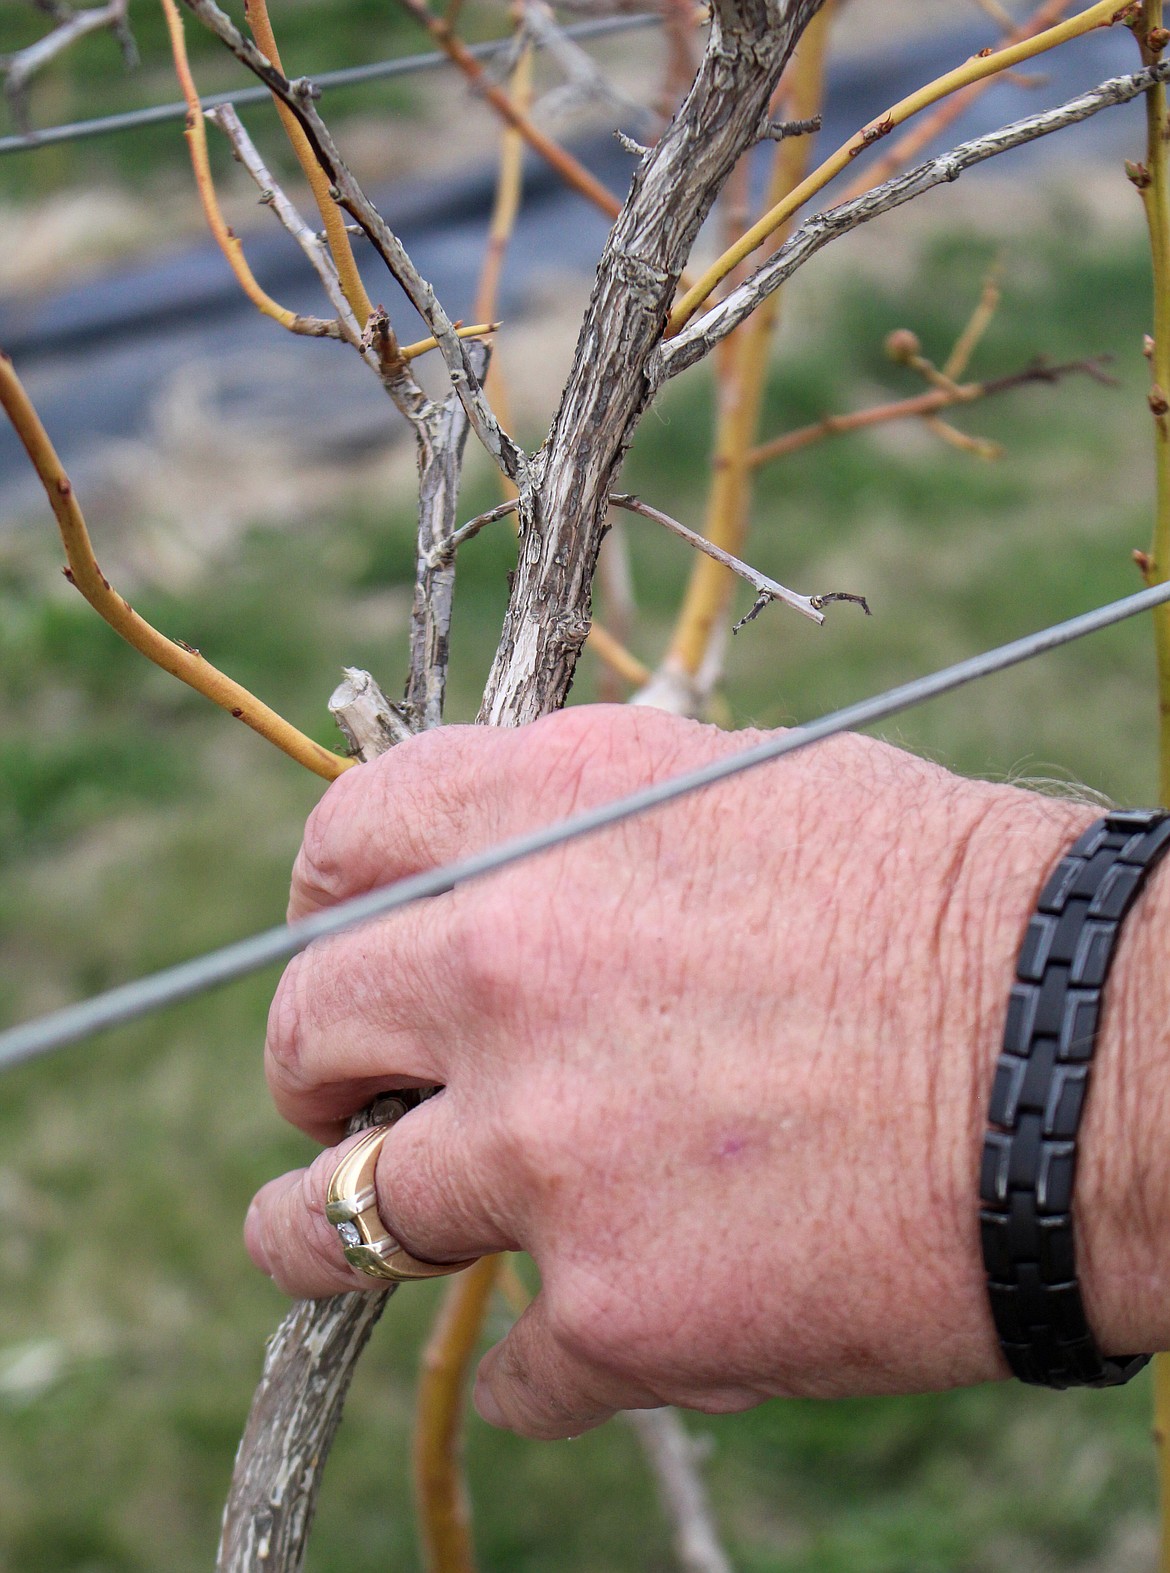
[0,209,1154,1573]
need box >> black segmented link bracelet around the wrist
[980,810,1170,1387]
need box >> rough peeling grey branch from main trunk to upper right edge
[649,63,1170,387]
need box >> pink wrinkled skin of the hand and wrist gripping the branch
[245,706,1170,1438]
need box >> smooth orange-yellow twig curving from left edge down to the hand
[0,355,351,780]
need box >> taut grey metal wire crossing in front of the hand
[0,584,1170,1071]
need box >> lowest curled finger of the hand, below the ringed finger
[473,1293,662,1441]
